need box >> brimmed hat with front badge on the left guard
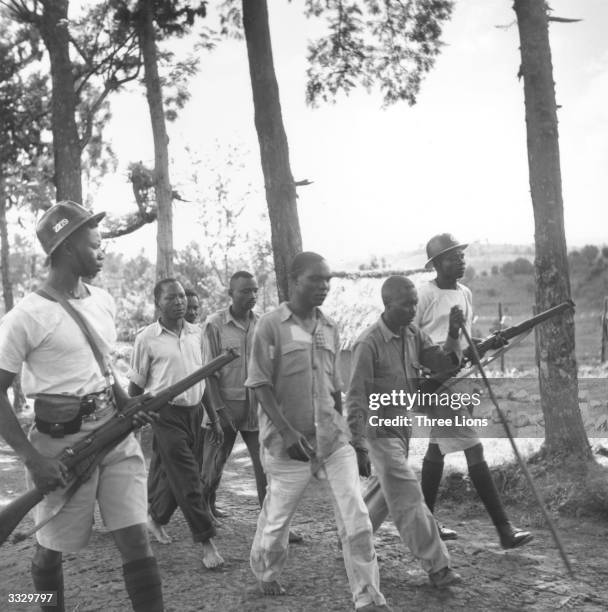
[36,200,106,255]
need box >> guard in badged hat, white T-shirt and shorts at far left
[0,201,163,612]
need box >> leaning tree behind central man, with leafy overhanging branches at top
[221,0,453,300]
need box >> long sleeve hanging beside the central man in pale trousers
[346,342,374,443]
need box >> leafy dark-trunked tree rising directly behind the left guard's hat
[0,0,159,234]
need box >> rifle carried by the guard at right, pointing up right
[420,300,574,393]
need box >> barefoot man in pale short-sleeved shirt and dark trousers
[129,278,224,569]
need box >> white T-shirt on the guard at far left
[0,285,116,397]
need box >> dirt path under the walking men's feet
[0,444,608,612]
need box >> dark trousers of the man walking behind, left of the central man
[202,427,266,508]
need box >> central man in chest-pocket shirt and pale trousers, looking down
[245,252,388,611]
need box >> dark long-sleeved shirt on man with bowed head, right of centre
[346,317,461,441]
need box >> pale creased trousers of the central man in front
[250,445,385,608]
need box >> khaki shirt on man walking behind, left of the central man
[205,308,259,431]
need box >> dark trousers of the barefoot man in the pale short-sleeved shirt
[148,405,215,542]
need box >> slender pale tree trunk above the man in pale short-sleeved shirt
[139,0,173,280]
